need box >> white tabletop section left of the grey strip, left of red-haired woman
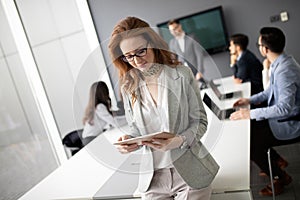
[20,124,141,200]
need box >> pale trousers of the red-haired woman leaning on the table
[142,168,212,200]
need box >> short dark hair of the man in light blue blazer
[259,27,285,53]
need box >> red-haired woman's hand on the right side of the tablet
[142,135,183,151]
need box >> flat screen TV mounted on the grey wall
[157,6,228,54]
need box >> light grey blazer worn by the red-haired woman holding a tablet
[122,65,219,192]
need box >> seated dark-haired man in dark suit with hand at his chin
[229,34,263,95]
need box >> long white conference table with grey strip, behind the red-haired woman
[20,77,252,200]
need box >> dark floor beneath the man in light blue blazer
[251,144,300,200]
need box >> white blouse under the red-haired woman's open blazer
[140,70,173,169]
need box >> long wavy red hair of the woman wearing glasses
[108,17,178,99]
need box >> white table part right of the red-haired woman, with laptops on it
[201,77,250,199]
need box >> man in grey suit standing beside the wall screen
[168,20,204,81]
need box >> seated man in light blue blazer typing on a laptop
[230,27,300,196]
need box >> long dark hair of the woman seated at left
[83,81,112,124]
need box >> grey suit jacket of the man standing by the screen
[169,35,204,75]
